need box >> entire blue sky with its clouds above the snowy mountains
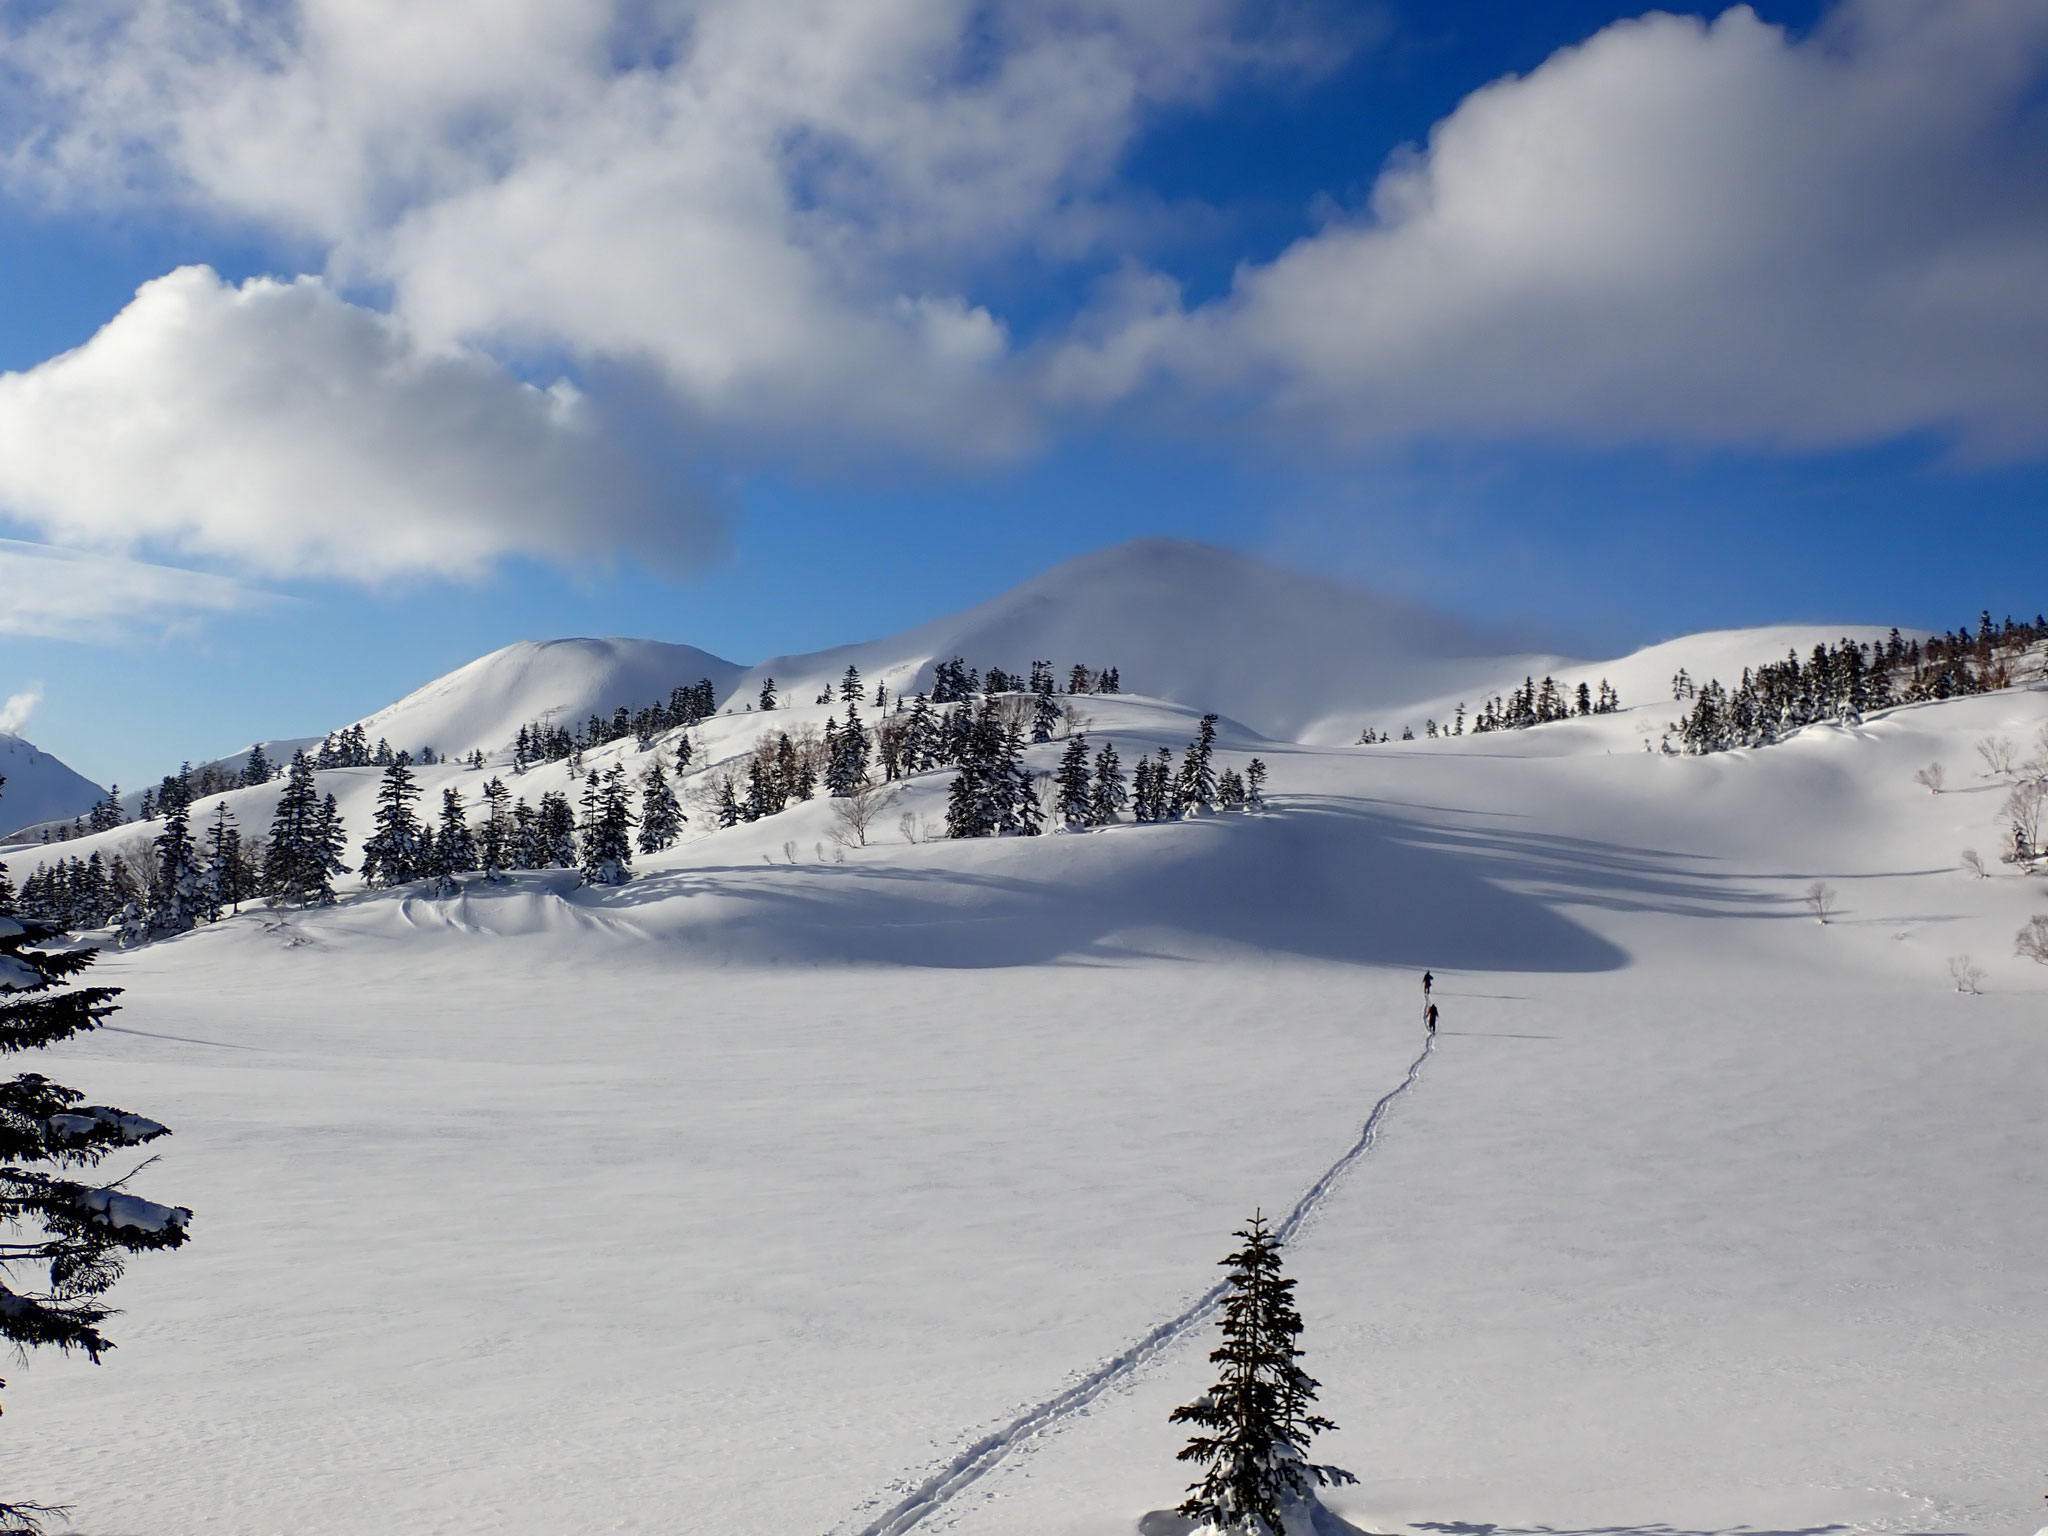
[0,0,2048,782]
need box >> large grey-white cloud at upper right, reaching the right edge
[1049,0,2048,455]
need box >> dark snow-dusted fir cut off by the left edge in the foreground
[0,782,193,1534]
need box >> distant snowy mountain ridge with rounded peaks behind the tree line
[299,539,1884,756]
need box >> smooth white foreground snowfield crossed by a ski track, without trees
[0,679,2048,1536]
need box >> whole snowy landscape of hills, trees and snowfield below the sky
[0,541,2048,1536]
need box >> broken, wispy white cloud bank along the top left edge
[0,0,1341,468]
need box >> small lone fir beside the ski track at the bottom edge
[1171,1214,1358,1536]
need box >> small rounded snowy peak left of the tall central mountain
[344,639,739,756]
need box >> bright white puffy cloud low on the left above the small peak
[0,266,717,582]
